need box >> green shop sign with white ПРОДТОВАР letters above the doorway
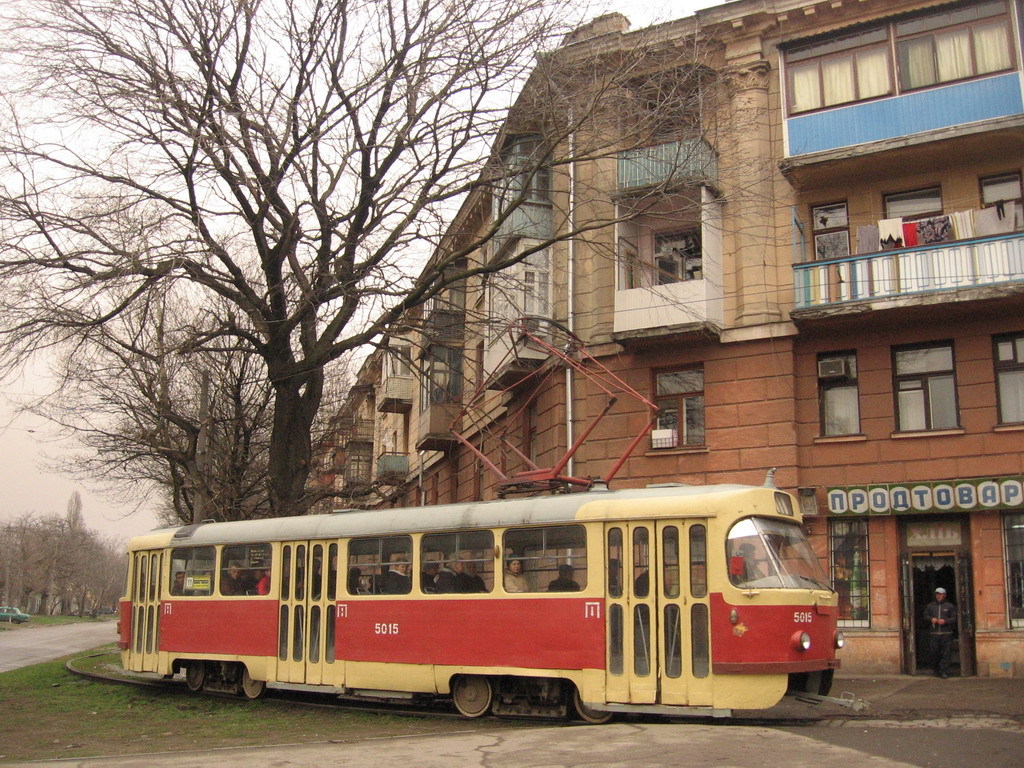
[827,475,1024,515]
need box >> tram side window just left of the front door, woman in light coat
[505,525,587,592]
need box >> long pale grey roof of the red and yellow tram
[132,484,777,545]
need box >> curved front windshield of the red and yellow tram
[726,517,831,590]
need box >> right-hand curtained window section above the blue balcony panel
[896,0,1013,91]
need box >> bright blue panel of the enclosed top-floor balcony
[786,73,1024,157]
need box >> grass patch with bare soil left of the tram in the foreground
[0,652,514,761]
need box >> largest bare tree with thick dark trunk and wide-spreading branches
[0,0,724,514]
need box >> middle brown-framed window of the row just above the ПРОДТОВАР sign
[893,344,959,432]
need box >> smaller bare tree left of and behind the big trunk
[32,291,280,523]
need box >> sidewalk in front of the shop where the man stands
[776,675,1024,719]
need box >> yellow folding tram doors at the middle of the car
[278,541,338,684]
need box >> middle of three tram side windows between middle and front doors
[420,530,495,594]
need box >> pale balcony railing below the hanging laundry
[793,232,1024,310]
